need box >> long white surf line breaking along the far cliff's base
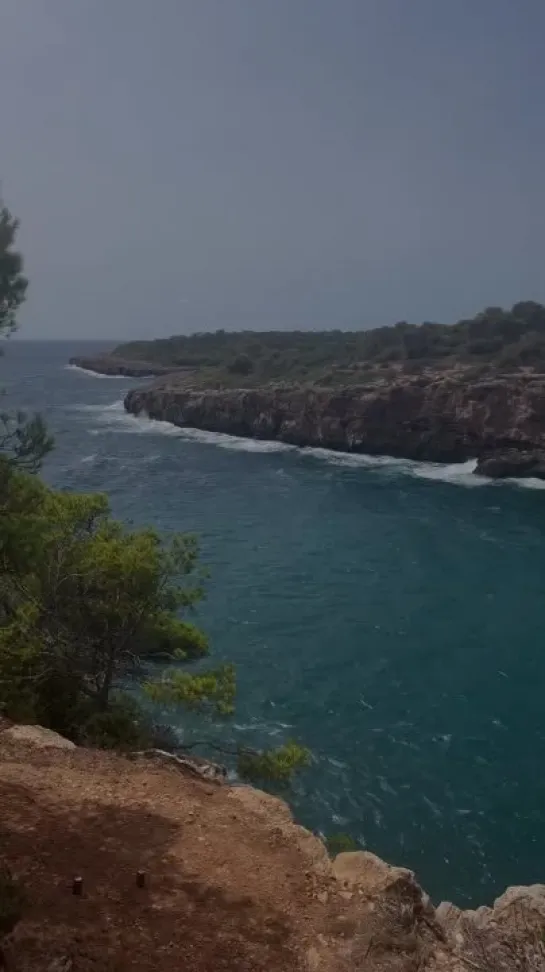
[72,399,545,490]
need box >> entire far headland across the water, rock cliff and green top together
[66,301,545,479]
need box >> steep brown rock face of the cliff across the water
[125,370,545,479]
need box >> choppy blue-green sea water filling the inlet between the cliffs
[6,343,545,903]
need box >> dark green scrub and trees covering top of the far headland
[107,301,545,386]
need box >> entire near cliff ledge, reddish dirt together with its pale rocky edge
[0,726,545,972]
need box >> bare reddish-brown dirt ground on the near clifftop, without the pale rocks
[0,733,338,972]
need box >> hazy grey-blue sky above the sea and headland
[0,0,545,340]
